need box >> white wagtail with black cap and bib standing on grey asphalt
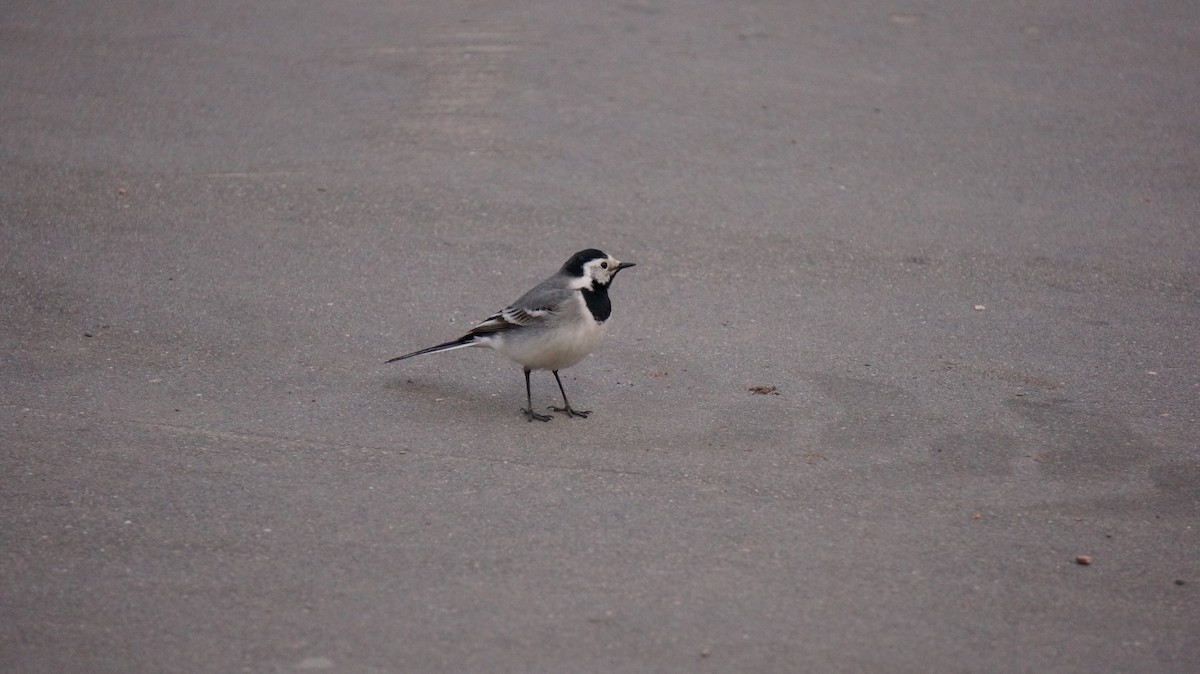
[386,248,634,421]
